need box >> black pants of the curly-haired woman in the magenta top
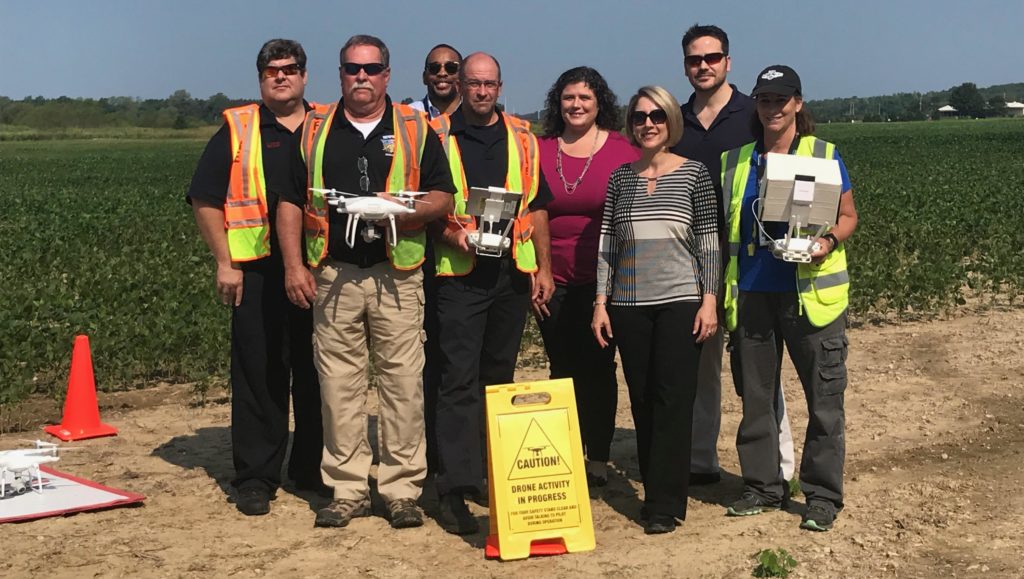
[539,284,618,462]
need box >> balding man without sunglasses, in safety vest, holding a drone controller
[433,52,554,535]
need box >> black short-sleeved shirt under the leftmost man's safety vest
[185,102,310,267]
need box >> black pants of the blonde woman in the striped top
[608,301,701,519]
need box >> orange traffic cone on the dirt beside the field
[43,336,118,442]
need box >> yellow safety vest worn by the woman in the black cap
[722,132,850,331]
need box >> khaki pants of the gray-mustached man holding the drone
[313,260,427,501]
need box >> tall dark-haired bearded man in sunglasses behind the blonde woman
[672,25,793,485]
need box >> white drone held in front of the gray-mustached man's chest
[309,188,429,247]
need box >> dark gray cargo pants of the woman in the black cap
[733,292,848,507]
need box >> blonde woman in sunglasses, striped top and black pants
[591,86,721,534]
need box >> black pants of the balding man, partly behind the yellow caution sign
[435,257,529,494]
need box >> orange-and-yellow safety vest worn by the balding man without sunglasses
[430,114,541,276]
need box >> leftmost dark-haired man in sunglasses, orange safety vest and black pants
[186,39,324,515]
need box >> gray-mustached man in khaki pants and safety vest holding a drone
[278,35,456,528]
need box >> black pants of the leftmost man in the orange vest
[231,263,324,491]
